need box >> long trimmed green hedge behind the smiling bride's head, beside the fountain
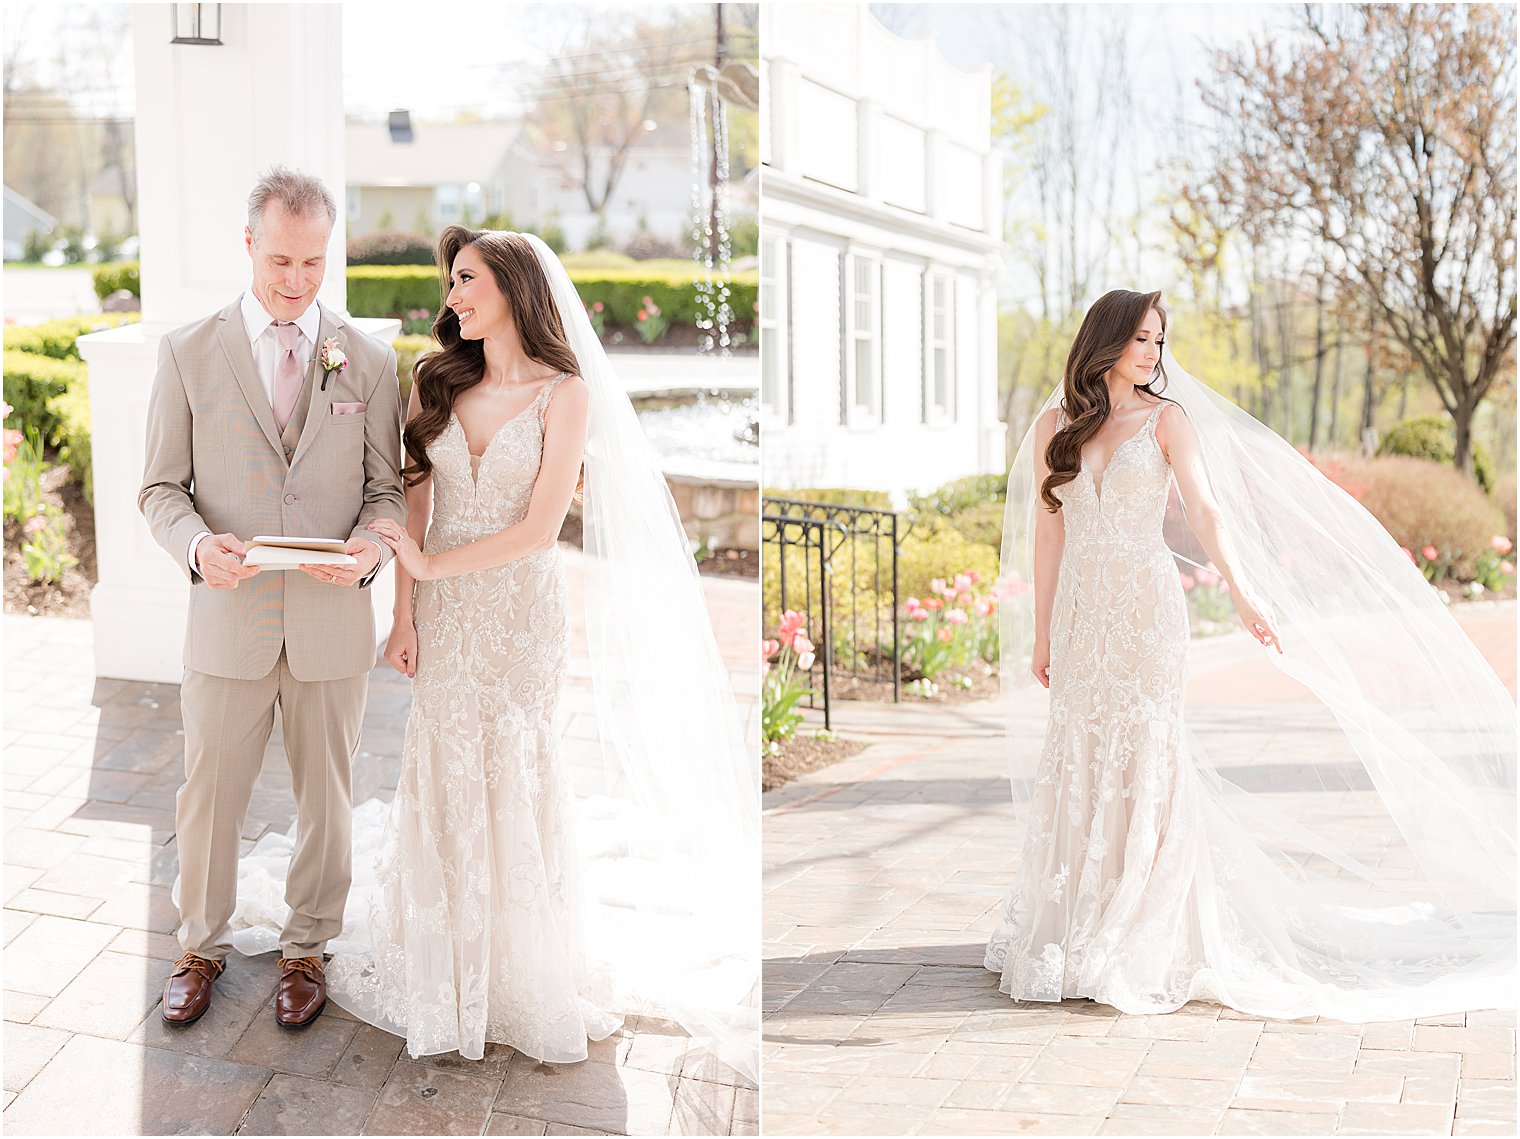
[348,265,760,333]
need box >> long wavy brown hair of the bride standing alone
[1040,289,1172,514]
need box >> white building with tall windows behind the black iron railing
[760,3,1003,494]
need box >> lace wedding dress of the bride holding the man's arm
[224,377,622,1063]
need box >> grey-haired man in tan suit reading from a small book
[138,169,406,1025]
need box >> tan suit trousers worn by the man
[175,647,369,960]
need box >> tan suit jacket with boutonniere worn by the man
[137,301,406,681]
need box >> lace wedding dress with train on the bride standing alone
[985,403,1512,1020]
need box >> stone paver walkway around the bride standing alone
[762,604,1515,1134]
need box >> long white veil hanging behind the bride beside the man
[524,234,760,1080]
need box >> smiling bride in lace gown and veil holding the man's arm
[224,227,758,1078]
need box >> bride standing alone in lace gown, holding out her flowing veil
[986,290,1515,1020]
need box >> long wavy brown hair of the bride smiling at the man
[401,225,581,487]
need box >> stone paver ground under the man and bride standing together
[5,555,758,1134]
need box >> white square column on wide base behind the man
[79,5,400,683]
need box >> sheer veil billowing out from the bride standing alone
[1000,350,1515,1020]
